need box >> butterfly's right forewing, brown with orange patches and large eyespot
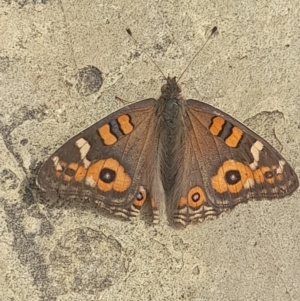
[187,100,299,199]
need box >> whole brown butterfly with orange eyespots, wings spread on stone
[37,28,299,226]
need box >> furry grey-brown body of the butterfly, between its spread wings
[151,78,187,215]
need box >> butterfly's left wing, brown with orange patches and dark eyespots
[37,99,155,216]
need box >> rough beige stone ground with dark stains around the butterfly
[0,0,300,301]
